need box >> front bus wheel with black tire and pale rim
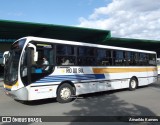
[57,83,75,103]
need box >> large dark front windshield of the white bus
[4,39,26,85]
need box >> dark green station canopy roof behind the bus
[0,20,160,57]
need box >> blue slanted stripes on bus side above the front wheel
[35,74,105,83]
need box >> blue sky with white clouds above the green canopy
[0,0,160,40]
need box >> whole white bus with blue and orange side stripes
[4,37,157,103]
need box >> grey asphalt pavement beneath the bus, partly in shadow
[0,79,160,125]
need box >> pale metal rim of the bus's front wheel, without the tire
[60,88,71,100]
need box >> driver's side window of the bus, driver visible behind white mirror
[30,43,54,83]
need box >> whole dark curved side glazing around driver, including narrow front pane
[21,43,54,86]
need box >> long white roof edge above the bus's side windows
[19,36,156,54]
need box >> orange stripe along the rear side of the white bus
[93,67,157,73]
